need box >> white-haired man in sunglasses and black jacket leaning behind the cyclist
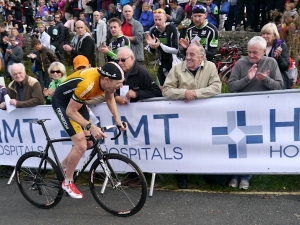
[115,47,162,105]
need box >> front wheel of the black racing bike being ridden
[89,153,147,217]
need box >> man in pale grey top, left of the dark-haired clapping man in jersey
[93,11,107,66]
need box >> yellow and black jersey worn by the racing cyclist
[53,68,104,105]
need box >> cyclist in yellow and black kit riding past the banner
[52,62,125,198]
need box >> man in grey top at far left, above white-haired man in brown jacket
[4,35,23,79]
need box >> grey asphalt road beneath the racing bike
[0,178,300,225]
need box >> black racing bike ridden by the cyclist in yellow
[15,119,147,217]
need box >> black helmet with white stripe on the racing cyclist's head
[97,62,124,80]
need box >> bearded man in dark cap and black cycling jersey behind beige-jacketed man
[179,5,219,61]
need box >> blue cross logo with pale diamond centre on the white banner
[212,111,263,158]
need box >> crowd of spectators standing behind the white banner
[0,0,300,189]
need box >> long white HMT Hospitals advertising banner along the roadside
[0,91,300,174]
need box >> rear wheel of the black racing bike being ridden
[15,152,64,209]
